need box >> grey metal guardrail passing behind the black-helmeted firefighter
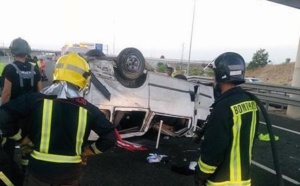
[188,76,300,108]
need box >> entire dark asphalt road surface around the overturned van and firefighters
[40,62,300,186]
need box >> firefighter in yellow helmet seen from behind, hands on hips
[0,53,116,186]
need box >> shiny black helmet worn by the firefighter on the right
[208,52,245,85]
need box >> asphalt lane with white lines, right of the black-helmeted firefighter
[253,115,300,185]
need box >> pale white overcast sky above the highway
[0,0,300,63]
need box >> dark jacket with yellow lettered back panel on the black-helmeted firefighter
[198,87,259,186]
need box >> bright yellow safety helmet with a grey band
[53,52,90,89]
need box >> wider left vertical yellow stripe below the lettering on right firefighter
[230,114,242,181]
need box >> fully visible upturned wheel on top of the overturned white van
[116,48,145,80]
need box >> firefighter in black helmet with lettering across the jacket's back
[194,52,258,186]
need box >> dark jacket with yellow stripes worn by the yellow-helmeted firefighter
[0,93,116,183]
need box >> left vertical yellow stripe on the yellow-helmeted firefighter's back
[40,99,53,153]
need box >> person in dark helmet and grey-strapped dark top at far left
[0,38,42,185]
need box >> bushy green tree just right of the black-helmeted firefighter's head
[247,49,269,70]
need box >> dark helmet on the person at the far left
[9,37,31,56]
